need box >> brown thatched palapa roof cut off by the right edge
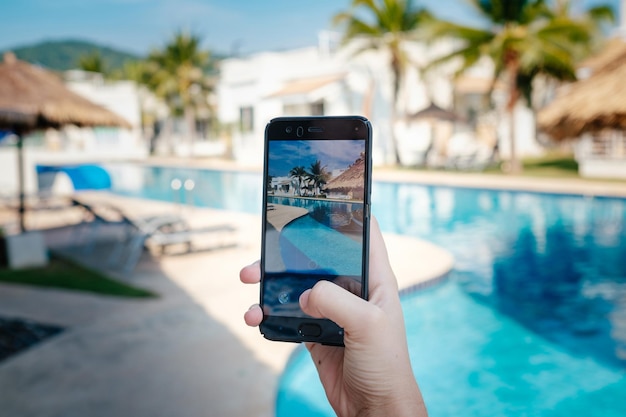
[537,39,626,140]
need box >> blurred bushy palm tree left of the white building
[147,32,210,145]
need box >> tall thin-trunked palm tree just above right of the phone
[333,0,432,164]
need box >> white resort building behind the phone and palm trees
[217,33,541,165]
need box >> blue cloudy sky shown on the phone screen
[268,140,365,177]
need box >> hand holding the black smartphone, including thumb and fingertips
[240,219,427,416]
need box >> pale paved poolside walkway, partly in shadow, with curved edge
[0,195,452,417]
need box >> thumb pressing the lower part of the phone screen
[300,281,382,336]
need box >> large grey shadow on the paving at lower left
[0,223,277,417]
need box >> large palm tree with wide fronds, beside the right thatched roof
[425,0,613,172]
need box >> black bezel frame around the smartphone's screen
[259,116,372,346]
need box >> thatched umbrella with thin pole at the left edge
[0,52,131,231]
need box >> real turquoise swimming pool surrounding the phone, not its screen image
[108,166,626,417]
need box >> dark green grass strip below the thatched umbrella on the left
[0,257,156,298]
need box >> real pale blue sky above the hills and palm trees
[0,0,620,55]
